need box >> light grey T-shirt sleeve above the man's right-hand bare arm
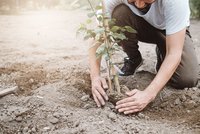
[164,0,190,35]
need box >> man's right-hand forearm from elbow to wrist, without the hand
[146,53,181,97]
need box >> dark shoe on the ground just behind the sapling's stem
[119,56,143,76]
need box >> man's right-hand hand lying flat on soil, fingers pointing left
[116,89,155,114]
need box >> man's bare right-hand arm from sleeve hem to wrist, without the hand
[146,29,186,95]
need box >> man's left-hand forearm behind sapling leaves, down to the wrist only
[89,43,101,78]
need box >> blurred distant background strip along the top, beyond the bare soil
[0,0,200,18]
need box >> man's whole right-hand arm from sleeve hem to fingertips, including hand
[116,28,186,114]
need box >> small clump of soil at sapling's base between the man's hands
[107,85,130,105]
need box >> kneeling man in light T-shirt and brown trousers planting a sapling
[89,0,198,114]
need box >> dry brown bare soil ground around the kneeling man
[0,10,200,134]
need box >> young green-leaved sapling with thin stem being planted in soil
[77,0,136,102]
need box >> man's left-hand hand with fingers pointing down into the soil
[92,76,108,107]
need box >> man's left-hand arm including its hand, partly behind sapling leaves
[89,43,108,107]
